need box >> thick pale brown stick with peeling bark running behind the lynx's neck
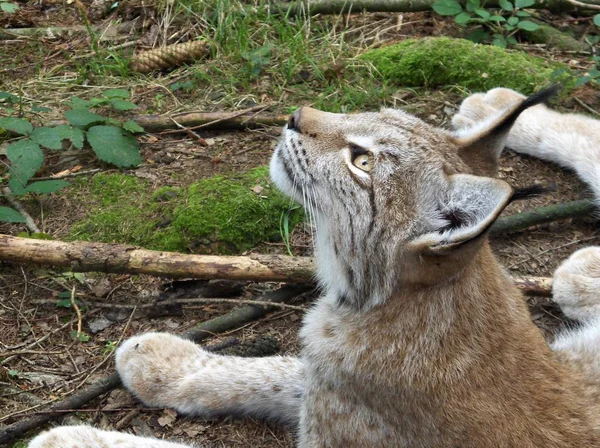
[0,233,556,293]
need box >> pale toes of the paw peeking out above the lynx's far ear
[452,88,525,129]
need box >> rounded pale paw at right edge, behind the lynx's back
[552,246,600,321]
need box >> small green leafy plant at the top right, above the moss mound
[433,0,539,48]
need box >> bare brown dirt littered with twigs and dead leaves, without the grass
[0,2,600,448]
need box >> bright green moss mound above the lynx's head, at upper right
[361,37,565,94]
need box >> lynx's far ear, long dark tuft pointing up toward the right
[456,86,558,176]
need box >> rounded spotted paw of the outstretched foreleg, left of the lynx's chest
[116,333,210,408]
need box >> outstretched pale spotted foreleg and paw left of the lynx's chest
[116,333,304,424]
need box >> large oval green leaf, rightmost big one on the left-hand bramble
[87,126,142,167]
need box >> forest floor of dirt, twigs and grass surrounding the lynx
[0,0,600,448]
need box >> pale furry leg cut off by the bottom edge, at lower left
[28,426,191,448]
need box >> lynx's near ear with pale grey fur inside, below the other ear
[409,174,513,256]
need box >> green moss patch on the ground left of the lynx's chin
[69,167,302,254]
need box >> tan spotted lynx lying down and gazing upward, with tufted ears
[30,91,600,448]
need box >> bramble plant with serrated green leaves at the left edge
[0,89,144,222]
